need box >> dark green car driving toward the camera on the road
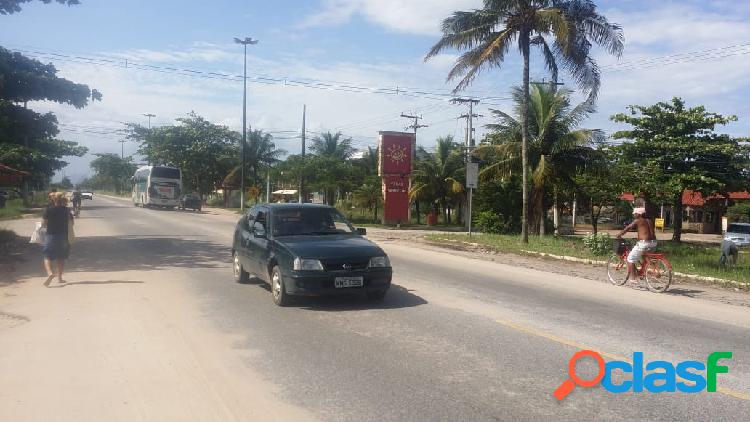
[232,204,393,306]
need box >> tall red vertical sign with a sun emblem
[378,132,416,224]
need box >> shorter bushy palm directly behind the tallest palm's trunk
[477,84,604,234]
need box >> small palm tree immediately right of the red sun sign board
[409,136,464,223]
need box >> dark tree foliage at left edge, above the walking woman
[0,47,101,195]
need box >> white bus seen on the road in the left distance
[133,166,182,208]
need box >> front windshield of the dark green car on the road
[272,208,355,236]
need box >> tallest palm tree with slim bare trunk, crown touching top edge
[425,0,623,242]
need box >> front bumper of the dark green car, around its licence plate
[284,268,393,296]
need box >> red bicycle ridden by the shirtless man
[607,239,673,293]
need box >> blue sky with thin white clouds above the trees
[0,0,750,182]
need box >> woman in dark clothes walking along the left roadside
[42,192,73,286]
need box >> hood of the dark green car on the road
[275,235,385,258]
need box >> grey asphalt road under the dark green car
[1,198,750,421]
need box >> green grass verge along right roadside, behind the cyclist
[425,234,750,283]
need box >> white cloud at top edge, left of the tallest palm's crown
[300,0,482,35]
